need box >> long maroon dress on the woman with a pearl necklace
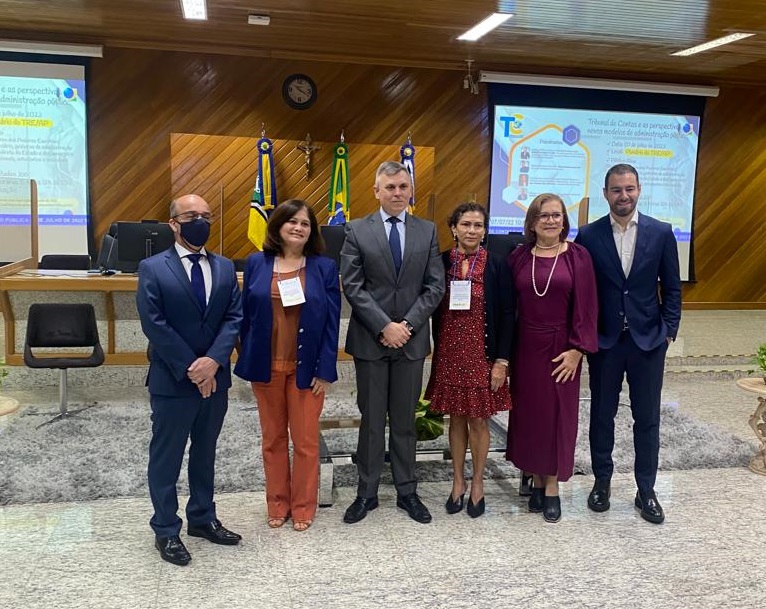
[506,243,598,482]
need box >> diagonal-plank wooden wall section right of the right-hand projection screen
[684,88,766,303]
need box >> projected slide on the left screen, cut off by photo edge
[0,62,88,254]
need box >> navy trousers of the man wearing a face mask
[148,391,228,537]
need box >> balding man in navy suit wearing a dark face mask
[136,195,242,565]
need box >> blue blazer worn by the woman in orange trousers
[234,252,340,389]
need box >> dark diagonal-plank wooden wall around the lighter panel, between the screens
[88,49,489,252]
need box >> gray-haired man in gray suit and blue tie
[340,161,444,524]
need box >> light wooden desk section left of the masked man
[0,271,147,366]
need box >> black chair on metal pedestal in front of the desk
[24,303,104,428]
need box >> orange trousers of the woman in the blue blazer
[252,369,324,521]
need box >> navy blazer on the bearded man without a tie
[575,213,681,351]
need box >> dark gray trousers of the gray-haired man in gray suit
[354,351,423,498]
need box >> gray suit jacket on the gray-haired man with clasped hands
[340,210,444,360]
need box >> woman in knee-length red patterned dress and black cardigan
[426,203,514,518]
